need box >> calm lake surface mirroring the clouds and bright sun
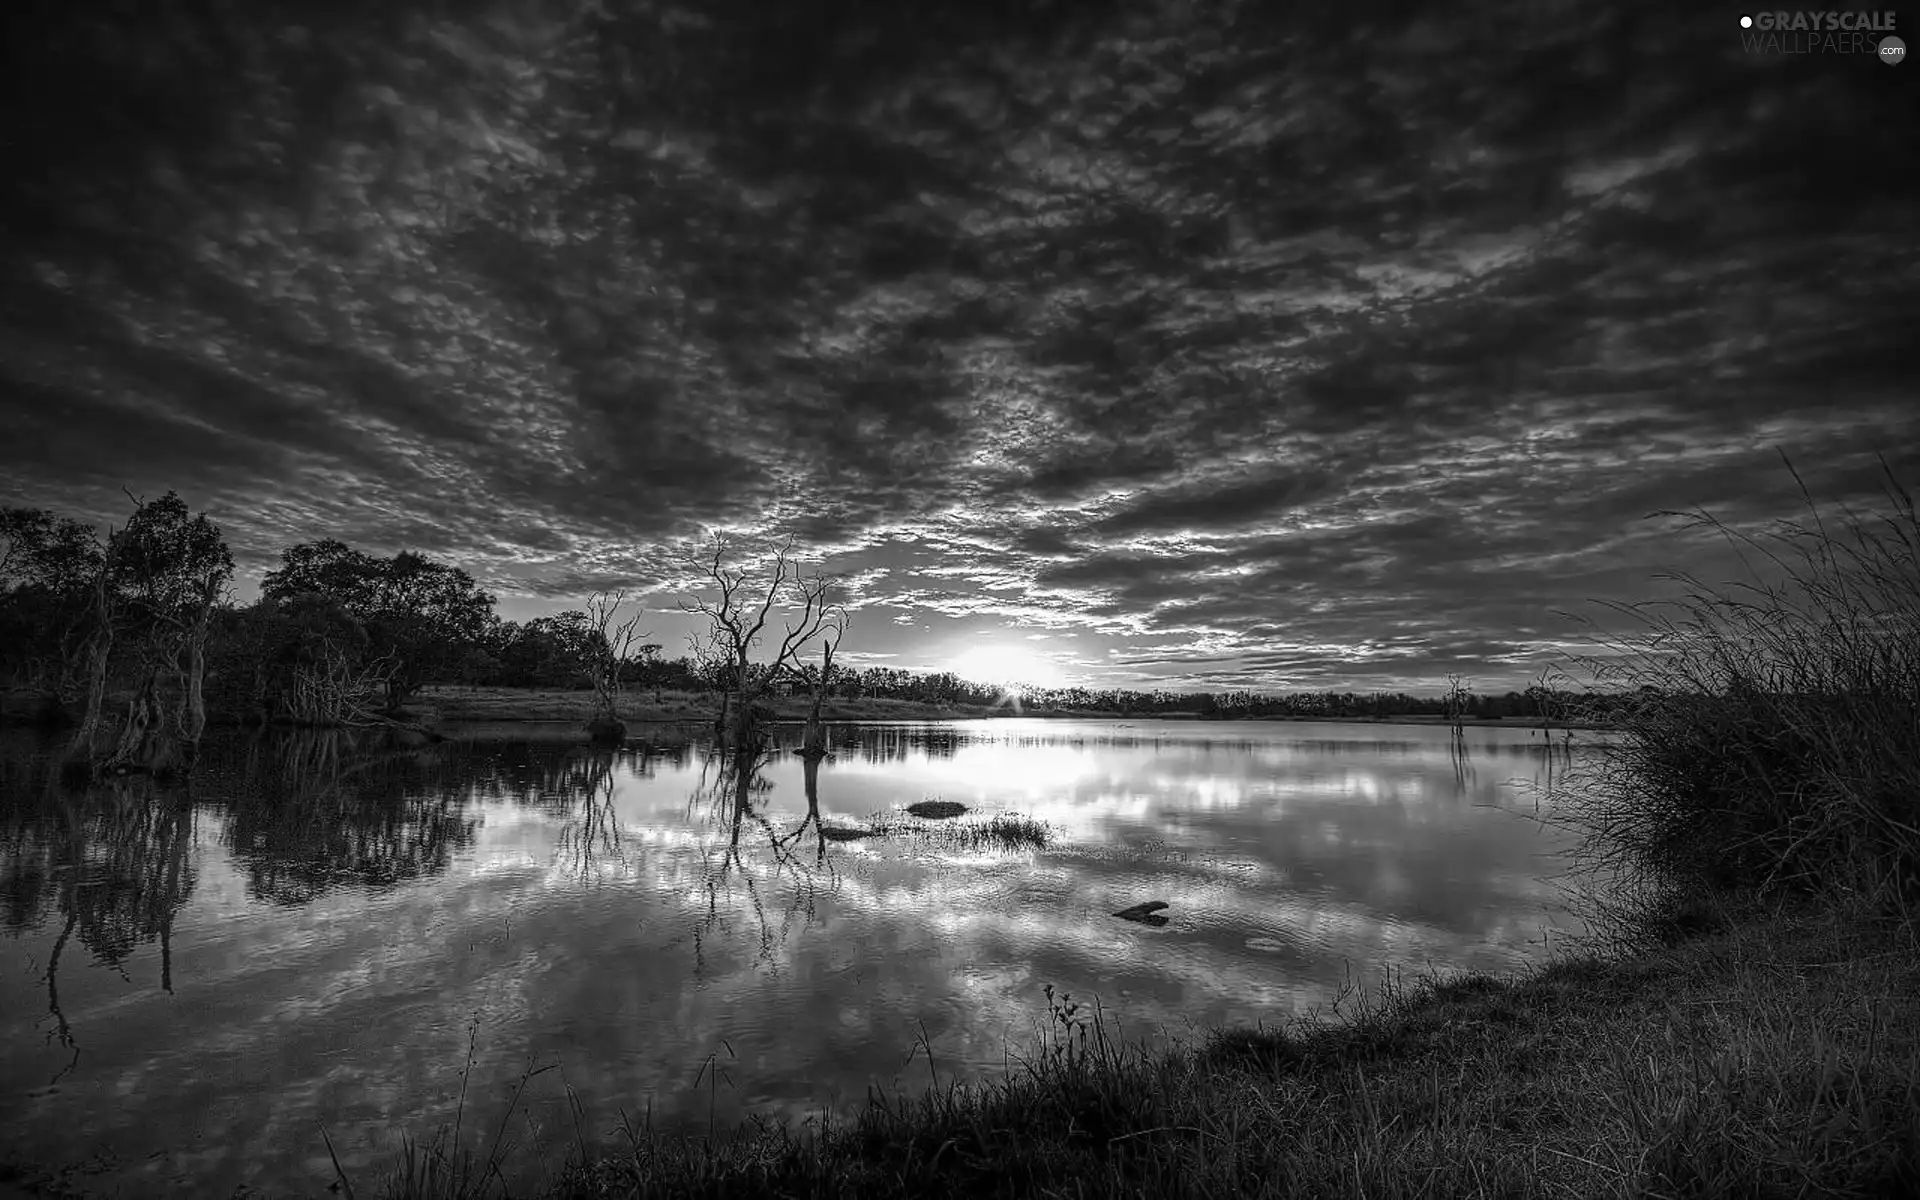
[0,720,1592,1196]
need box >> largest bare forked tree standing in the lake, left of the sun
[680,534,847,749]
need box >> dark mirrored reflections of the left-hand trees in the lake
[0,730,897,1079]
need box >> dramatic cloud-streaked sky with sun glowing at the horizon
[0,0,1920,693]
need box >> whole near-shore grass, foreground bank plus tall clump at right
[362,453,1920,1200]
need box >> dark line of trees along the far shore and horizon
[0,492,1651,766]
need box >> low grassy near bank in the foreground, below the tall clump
[357,904,1920,1200]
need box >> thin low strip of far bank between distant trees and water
[407,685,1607,732]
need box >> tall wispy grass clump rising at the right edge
[1565,463,1920,912]
